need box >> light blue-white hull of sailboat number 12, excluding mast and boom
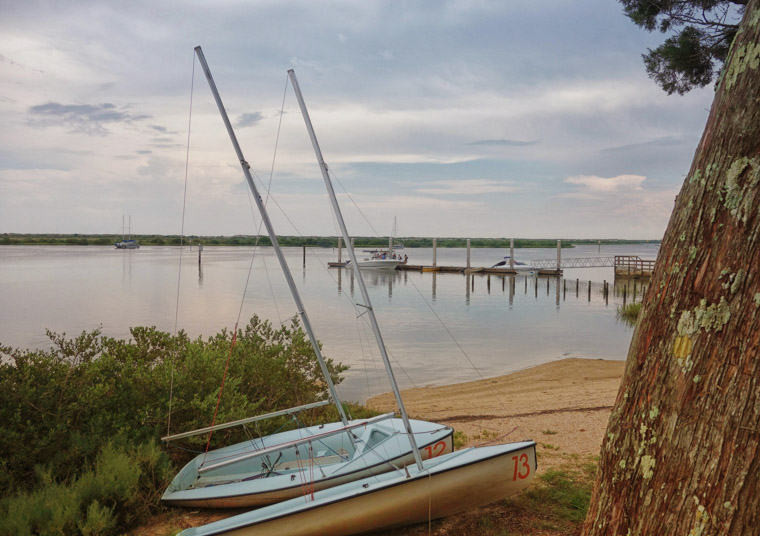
[161,419,453,508]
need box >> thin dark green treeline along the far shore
[0,233,659,248]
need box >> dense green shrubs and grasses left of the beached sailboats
[0,317,350,536]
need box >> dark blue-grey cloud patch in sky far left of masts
[29,102,150,136]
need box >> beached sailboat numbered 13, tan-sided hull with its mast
[176,53,536,536]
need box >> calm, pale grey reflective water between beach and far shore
[0,244,658,400]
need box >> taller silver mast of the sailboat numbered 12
[195,46,348,425]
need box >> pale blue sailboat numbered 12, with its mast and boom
[161,47,454,508]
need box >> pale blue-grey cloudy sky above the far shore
[0,0,714,239]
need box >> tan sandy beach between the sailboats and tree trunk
[366,359,625,468]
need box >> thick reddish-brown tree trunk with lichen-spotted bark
[584,0,760,536]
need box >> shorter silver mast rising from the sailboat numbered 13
[288,69,423,471]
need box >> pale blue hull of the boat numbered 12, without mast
[161,419,454,508]
